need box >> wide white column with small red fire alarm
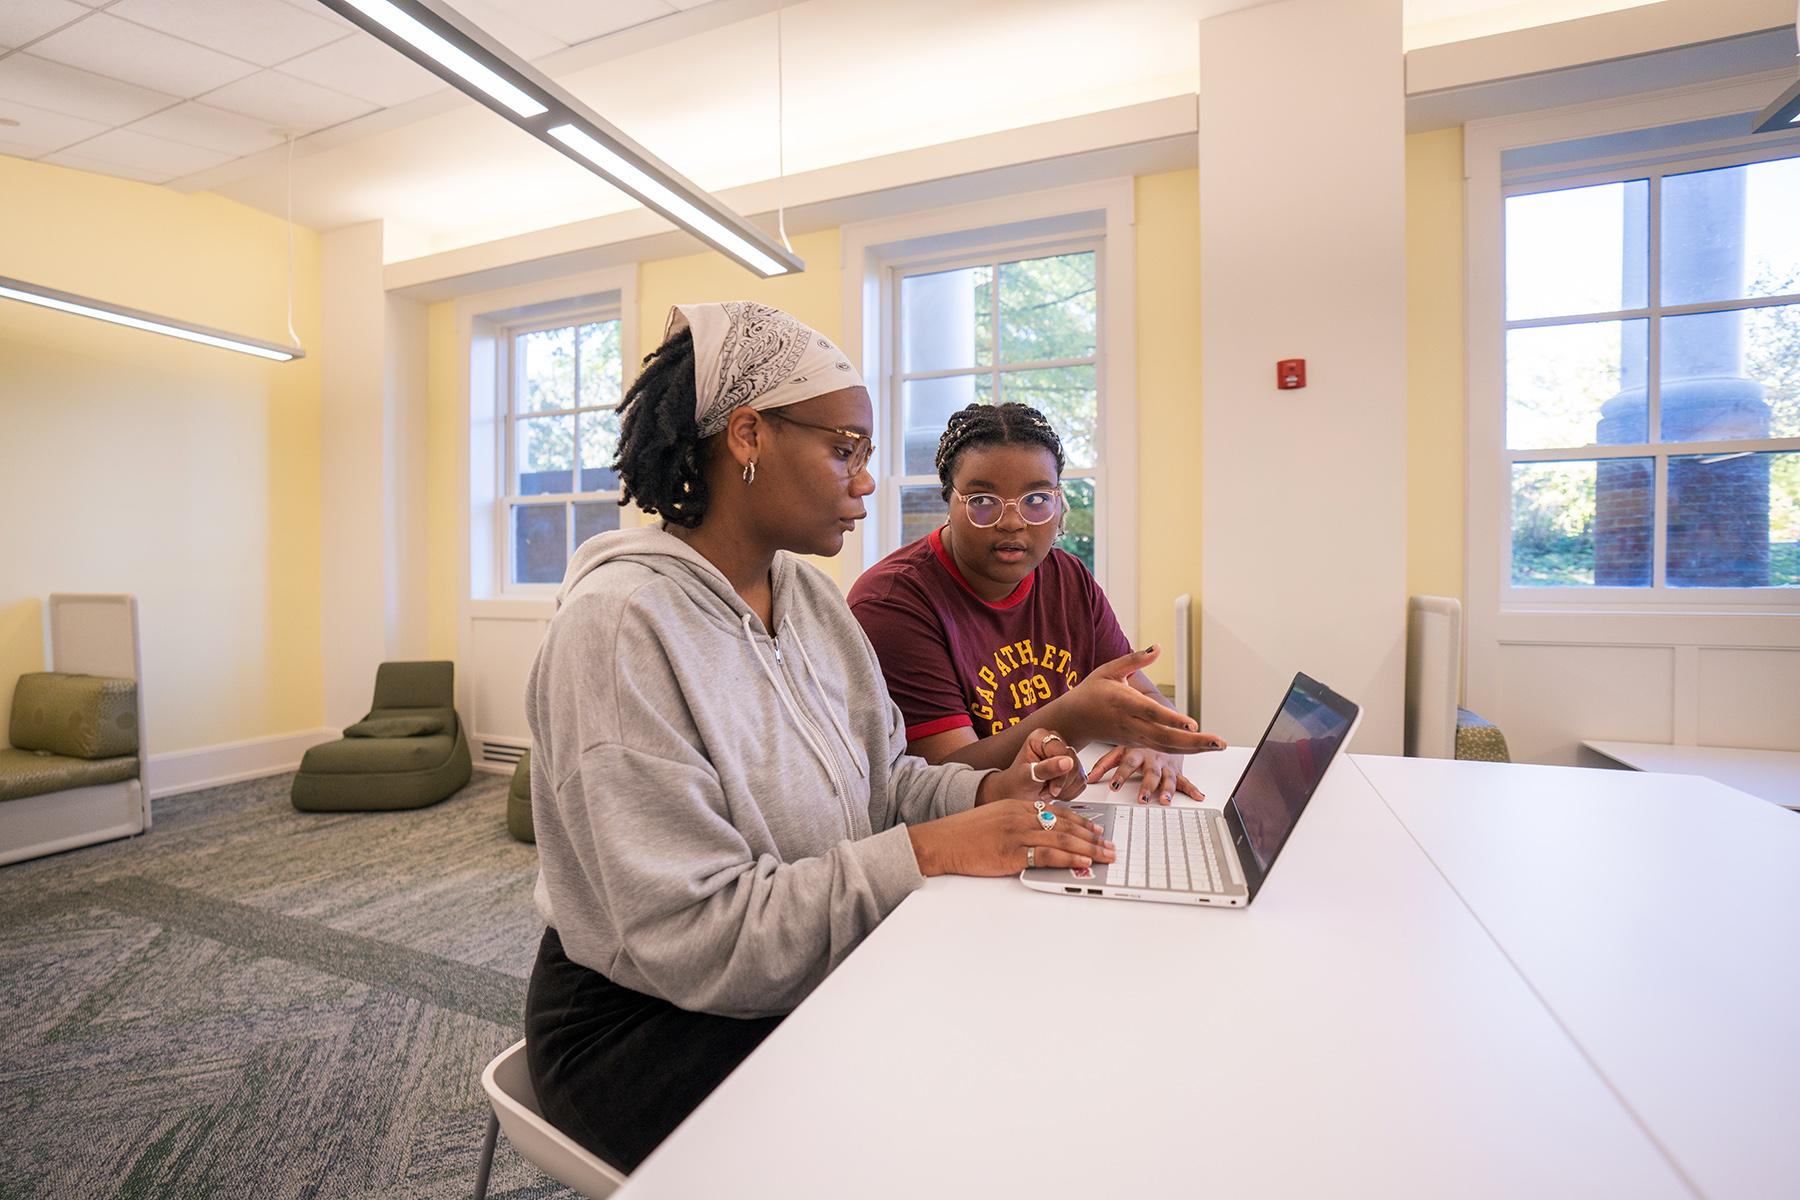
[1199,0,1406,754]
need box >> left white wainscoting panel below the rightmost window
[1476,642,1676,766]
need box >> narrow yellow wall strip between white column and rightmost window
[1406,128,1463,599]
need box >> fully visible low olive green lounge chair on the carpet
[293,662,472,813]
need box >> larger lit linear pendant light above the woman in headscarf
[319,0,806,279]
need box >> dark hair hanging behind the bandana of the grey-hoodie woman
[612,329,709,529]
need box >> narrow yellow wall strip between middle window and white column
[1136,171,1201,685]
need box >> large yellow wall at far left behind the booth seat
[0,157,320,752]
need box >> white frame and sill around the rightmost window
[1463,72,1800,745]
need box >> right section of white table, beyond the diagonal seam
[1360,757,1800,1200]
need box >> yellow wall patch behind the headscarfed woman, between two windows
[637,228,844,583]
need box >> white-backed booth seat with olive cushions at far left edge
[0,592,149,864]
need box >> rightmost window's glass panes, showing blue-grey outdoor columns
[1503,149,1800,597]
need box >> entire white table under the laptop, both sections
[604,750,1800,1200]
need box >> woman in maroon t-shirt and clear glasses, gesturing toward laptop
[850,405,1224,804]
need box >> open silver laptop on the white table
[1019,675,1363,909]
